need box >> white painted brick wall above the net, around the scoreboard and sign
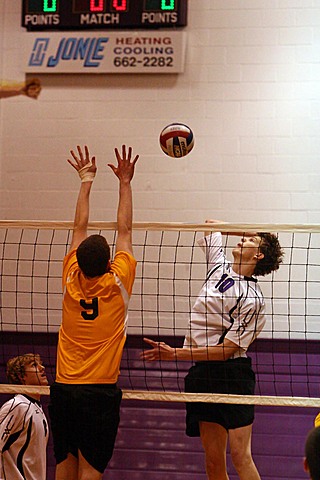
[0,0,320,223]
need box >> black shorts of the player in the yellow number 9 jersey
[49,382,122,473]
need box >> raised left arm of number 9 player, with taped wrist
[68,146,97,250]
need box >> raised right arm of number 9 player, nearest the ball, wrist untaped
[108,145,139,254]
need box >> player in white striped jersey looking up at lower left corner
[0,353,49,480]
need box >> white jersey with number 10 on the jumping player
[184,233,265,358]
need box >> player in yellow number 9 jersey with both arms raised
[49,145,139,480]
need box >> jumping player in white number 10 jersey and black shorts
[141,220,283,480]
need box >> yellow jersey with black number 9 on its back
[56,249,137,384]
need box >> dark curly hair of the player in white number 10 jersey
[253,233,284,276]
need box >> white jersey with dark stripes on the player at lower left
[0,394,49,480]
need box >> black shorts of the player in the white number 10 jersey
[185,358,255,437]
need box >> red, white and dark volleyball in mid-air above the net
[160,123,194,158]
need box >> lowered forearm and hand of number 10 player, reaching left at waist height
[140,338,239,361]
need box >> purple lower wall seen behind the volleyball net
[0,333,320,480]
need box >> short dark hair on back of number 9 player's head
[76,235,110,278]
